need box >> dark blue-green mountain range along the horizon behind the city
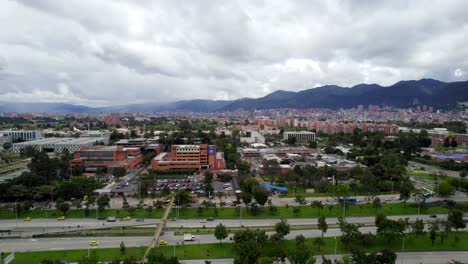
[0,79,468,113]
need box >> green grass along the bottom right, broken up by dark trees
[157,232,468,259]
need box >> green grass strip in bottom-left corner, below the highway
[7,247,146,264]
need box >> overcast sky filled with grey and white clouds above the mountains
[0,0,468,106]
